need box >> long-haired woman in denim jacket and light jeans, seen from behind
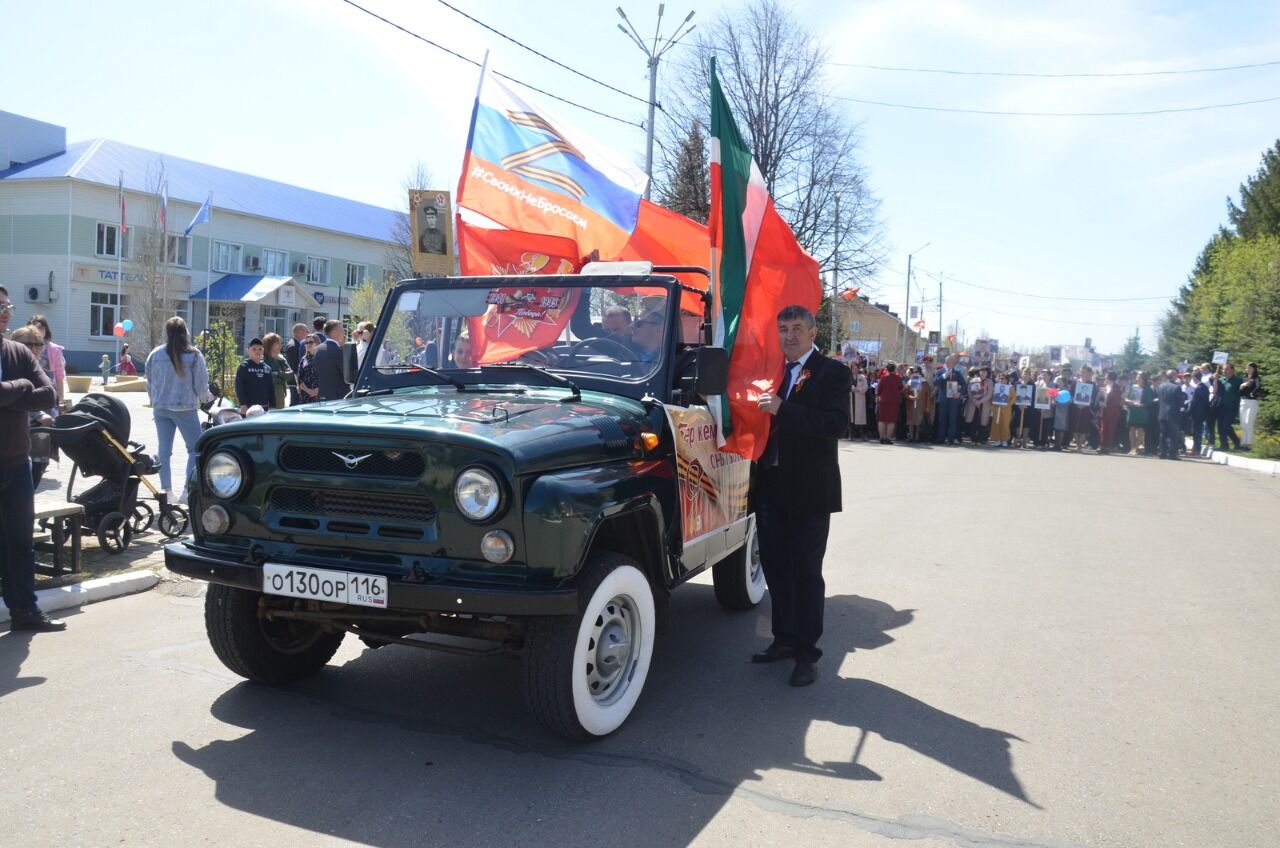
[145,315,212,503]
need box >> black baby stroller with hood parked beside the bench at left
[32,395,188,553]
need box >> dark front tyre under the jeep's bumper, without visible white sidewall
[205,583,346,684]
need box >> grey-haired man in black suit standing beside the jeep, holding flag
[751,306,850,687]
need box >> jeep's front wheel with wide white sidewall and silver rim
[525,553,657,739]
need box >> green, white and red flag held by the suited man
[707,59,822,460]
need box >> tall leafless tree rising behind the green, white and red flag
[659,0,884,287]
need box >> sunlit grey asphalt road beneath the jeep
[0,444,1280,848]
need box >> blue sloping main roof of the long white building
[0,138,403,241]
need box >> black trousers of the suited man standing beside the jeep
[755,468,831,662]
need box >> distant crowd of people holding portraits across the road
[847,355,1265,459]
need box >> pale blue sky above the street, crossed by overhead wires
[0,0,1280,351]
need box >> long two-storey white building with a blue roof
[0,111,401,370]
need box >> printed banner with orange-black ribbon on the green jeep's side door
[666,406,751,543]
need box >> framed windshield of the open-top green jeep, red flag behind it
[356,277,701,397]
